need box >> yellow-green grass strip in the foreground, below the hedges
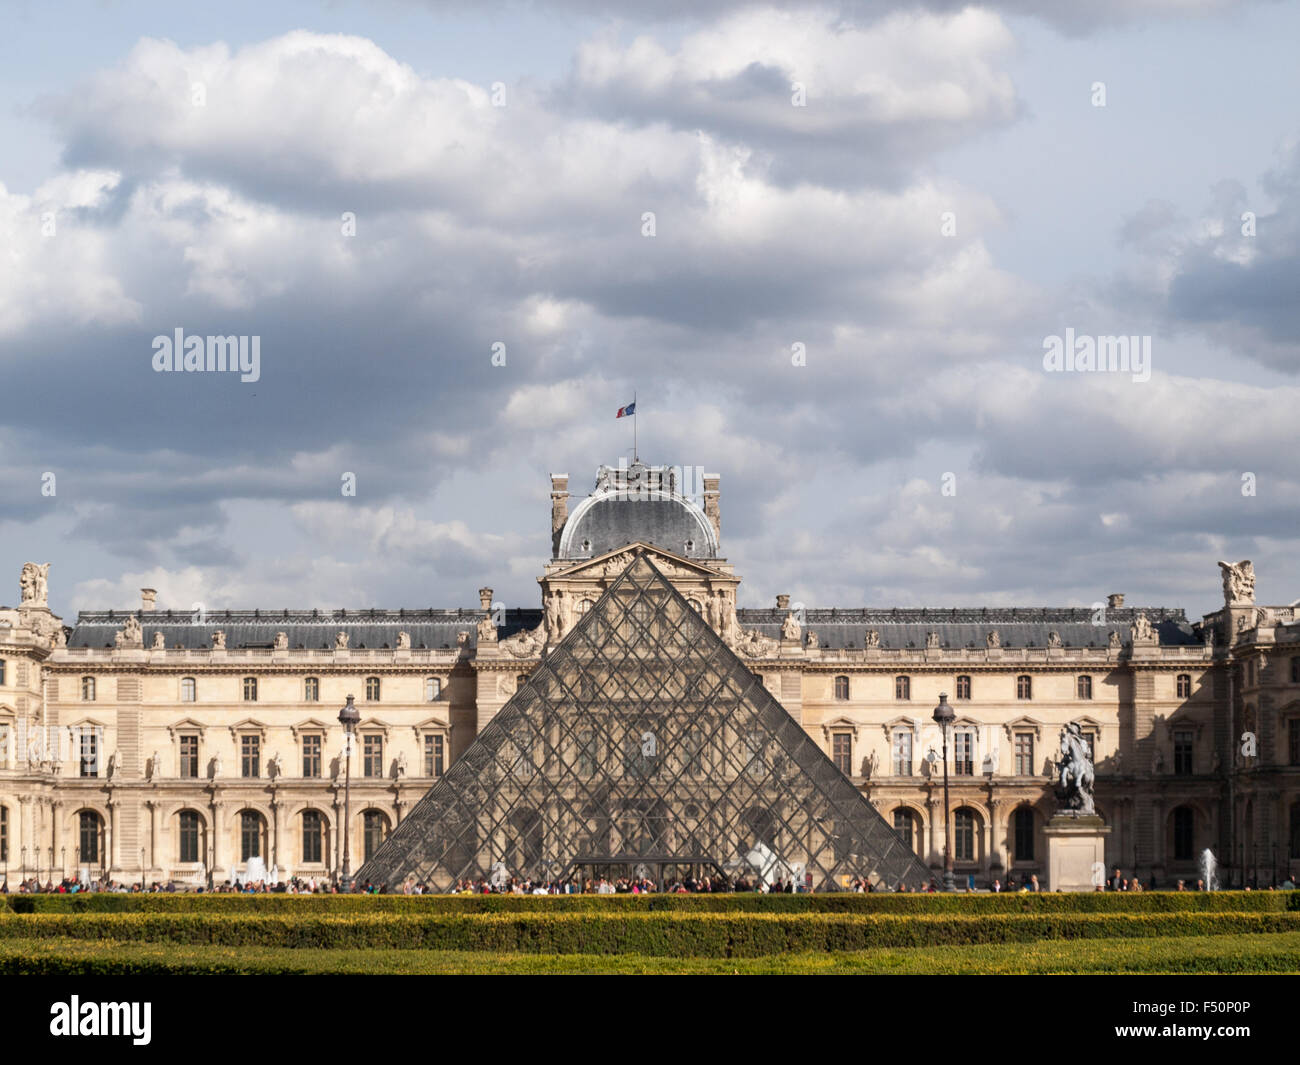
[0,932,1300,975]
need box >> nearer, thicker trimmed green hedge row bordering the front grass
[0,912,1300,957]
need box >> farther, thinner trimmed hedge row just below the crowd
[8,891,1300,914]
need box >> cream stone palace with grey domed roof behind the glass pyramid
[0,464,1300,886]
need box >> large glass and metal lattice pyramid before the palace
[356,550,931,891]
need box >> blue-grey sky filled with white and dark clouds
[0,0,1300,618]
